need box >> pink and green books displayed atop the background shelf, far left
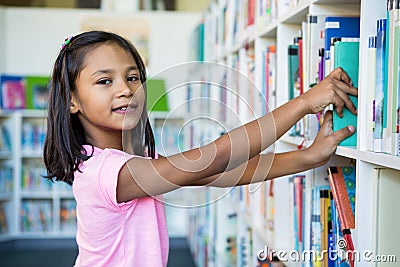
[0,75,49,109]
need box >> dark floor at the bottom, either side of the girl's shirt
[0,238,195,267]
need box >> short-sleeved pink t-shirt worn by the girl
[72,146,169,267]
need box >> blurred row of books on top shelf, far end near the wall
[197,0,304,60]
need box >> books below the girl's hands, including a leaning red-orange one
[289,166,356,267]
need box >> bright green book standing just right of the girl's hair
[146,79,169,111]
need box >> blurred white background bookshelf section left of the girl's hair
[0,110,76,241]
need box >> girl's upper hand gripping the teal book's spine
[299,68,358,117]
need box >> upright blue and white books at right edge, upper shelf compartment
[367,0,400,155]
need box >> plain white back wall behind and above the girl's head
[0,8,200,76]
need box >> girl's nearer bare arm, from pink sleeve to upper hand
[117,68,357,202]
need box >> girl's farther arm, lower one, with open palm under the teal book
[188,112,354,187]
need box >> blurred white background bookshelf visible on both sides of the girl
[0,110,186,242]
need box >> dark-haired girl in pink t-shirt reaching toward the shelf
[44,31,357,267]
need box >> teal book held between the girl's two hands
[333,42,360,146]
